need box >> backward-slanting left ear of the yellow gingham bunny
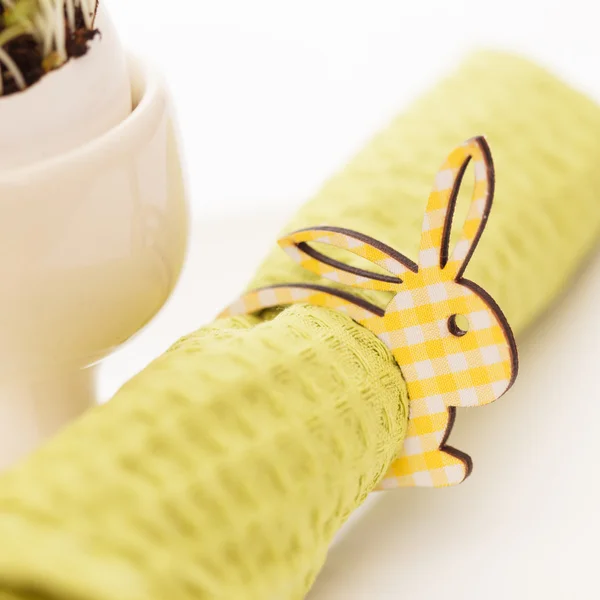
[279,226,417,291]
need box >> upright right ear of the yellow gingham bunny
[419,137,494,279]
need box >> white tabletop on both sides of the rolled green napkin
[100,212,600,600]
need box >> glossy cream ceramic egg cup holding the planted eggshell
[0,61,188,467]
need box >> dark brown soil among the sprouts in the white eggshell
[0,4,100,96]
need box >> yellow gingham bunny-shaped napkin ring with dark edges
[221,137,518,489]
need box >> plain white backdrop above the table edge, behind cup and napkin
[110,0,600,220]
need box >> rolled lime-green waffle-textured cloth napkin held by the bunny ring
[0,53,600,600]
